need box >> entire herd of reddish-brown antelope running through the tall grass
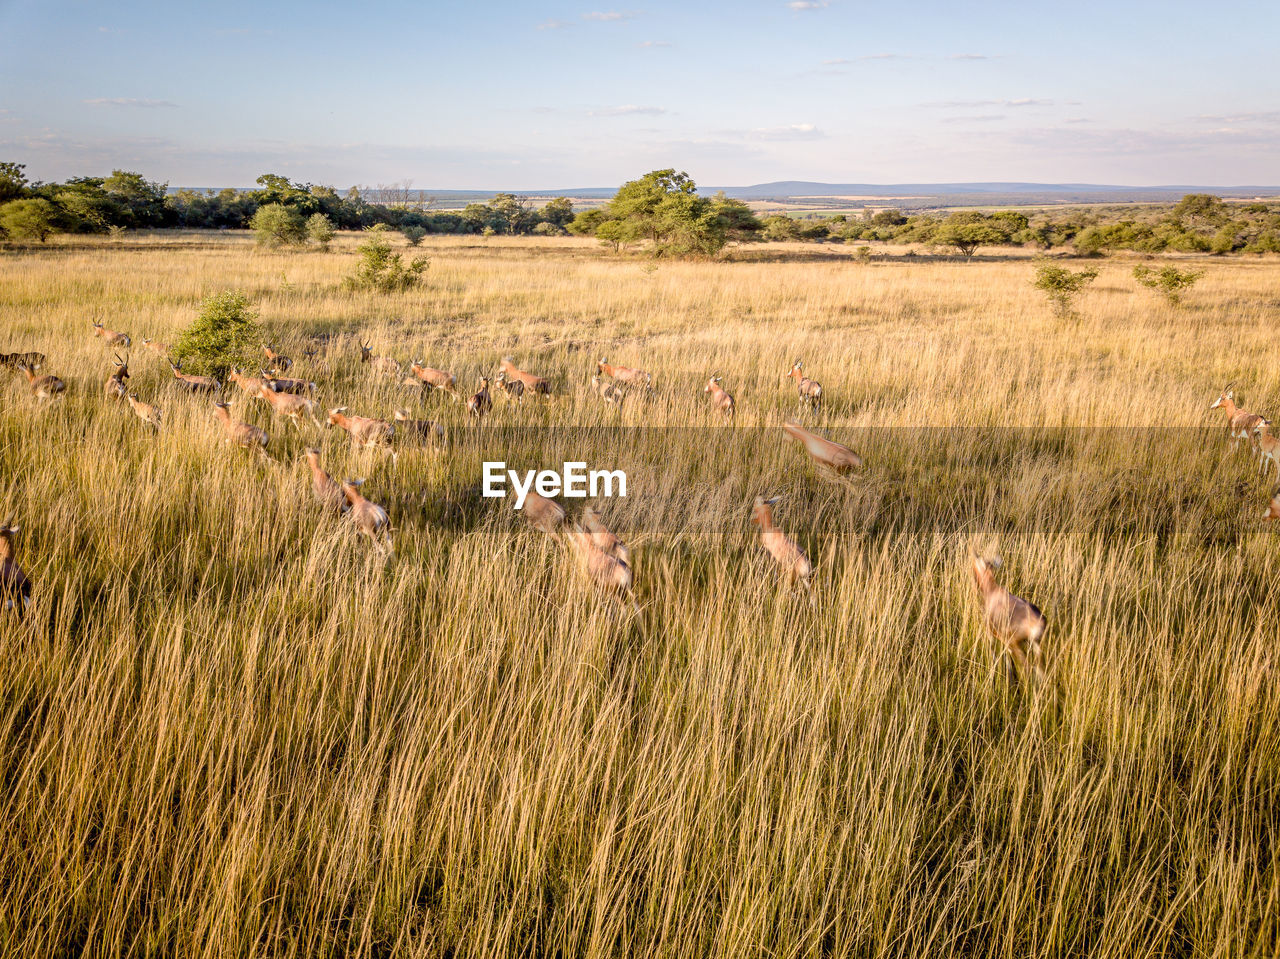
[0,321,1280,681]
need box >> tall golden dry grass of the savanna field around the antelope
[0,232,1280,959]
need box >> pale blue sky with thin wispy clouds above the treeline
[0,0,1280,191]
